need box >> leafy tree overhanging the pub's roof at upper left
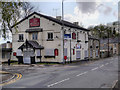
[0,0,33,38]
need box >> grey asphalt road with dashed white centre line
[3,56,118,88]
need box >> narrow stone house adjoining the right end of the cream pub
[88,35,100,60]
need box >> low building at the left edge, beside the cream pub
[0,41,12,62]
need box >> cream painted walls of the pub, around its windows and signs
[12,15,88,62]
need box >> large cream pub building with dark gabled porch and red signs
[11,12,89,64]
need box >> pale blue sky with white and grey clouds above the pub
[0,0,119,43]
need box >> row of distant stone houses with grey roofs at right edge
[100,37,120,57]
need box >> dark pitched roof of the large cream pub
[11,12,89,31]
